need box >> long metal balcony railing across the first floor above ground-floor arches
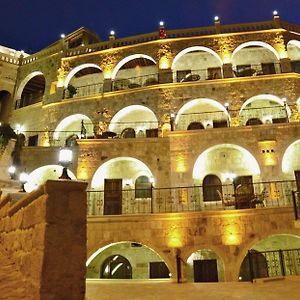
[87,181,296,215]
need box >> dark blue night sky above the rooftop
[0,0,300,53]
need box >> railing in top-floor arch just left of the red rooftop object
[113,73,158,91]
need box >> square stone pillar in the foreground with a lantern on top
[40,180,87,300]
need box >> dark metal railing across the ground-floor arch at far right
[246,249,300,280]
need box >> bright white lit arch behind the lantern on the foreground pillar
[24,165,76,193]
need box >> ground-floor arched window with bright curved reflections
[100,255,132,279]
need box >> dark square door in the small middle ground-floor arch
[194,259,219,282]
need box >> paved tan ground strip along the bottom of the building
[86,276,300,300]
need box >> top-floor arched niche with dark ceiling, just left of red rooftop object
[112,54,158,90]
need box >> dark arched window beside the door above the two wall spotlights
[203,175,222,201]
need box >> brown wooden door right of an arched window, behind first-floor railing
[233,176,254,208]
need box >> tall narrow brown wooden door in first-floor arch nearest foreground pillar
[103,179,122,215]
